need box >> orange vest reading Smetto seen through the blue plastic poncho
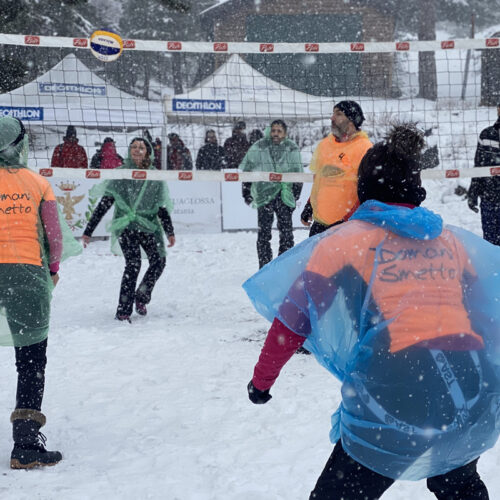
[307,221,483,352]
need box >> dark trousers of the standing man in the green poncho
[257,195,294,268]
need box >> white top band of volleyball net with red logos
[0,34,500,54]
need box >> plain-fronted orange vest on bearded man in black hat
[309,132,372,226]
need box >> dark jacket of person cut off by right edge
[468,118,500,204]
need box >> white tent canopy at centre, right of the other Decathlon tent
[164,54,333,119]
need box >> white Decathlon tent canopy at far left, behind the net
[0,54,164,127]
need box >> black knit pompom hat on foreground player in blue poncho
[358,123,426,206]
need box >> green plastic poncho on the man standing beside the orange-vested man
[240,130,304,208]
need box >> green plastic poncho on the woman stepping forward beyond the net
[90,138,173,258]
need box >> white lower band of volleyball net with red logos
[34,165,499,184]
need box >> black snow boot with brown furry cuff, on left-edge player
[10,408,62,469]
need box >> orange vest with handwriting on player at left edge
[0,168,55,266]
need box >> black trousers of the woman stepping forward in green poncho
[116,229,166,316]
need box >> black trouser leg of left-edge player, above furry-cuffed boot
[14,339,47,411]
